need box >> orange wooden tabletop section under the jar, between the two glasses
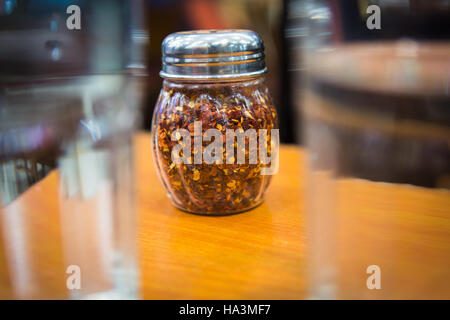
[137,136,305,299]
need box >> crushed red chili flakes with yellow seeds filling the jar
[152,77,278,215]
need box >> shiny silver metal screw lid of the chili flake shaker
[160,30,267,81]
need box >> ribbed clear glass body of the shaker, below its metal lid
[152,76,278,215]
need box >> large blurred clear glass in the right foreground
[292,1,450,299]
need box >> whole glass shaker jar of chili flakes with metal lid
[152,30,278,215]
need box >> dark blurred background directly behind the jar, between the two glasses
[144,0,295,143]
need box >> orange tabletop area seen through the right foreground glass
[337,179,450,299]
